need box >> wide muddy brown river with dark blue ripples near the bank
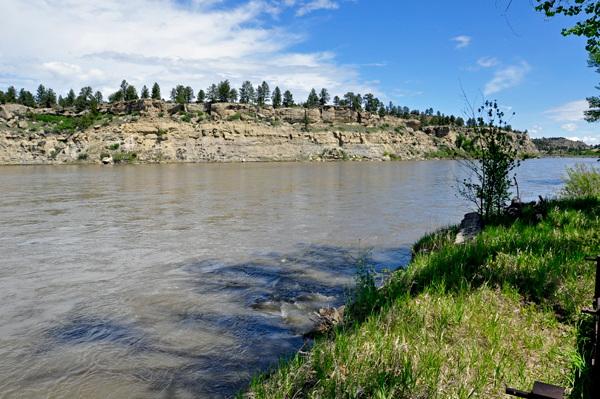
[0,159,594,398]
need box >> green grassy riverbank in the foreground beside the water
[240,197,600,398]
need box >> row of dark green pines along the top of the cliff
[0,79,478,130]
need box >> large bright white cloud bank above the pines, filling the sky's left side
[0,0,366,97]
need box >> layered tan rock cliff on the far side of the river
[0,100,536,164]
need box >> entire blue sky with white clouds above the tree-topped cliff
[0,0,600,144]
